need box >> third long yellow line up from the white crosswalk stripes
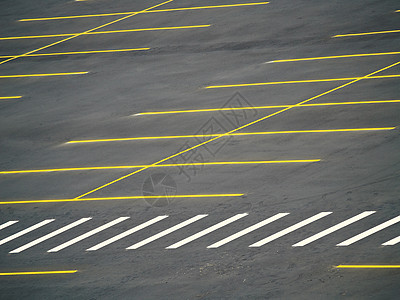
[66,127,396,144]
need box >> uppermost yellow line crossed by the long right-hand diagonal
[205,75,400,89]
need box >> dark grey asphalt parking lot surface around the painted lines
[0,0,400,299]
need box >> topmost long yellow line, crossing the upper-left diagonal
[19,2,269,22]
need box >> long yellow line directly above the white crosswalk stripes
[0,194,244,204]
